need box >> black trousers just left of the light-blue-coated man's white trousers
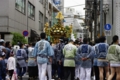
[28,66,38,77]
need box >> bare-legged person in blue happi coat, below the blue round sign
[95,36,109,80]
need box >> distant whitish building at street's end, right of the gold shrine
[64,8,84,39]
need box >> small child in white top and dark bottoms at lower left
[7,53,16,80]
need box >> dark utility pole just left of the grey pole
[94,0,97,41]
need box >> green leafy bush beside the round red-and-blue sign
[12,32,27,45]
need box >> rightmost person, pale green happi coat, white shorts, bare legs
[107,35,120,80]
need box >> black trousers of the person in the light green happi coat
[64,67,75,80]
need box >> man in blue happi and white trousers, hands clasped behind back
[77,38,94,80]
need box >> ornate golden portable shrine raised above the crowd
[44,12,72,43]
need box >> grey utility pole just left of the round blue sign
[100,0,103,36]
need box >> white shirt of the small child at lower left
[7,57,16,71]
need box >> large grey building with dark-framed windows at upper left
[0,0,63,42]
